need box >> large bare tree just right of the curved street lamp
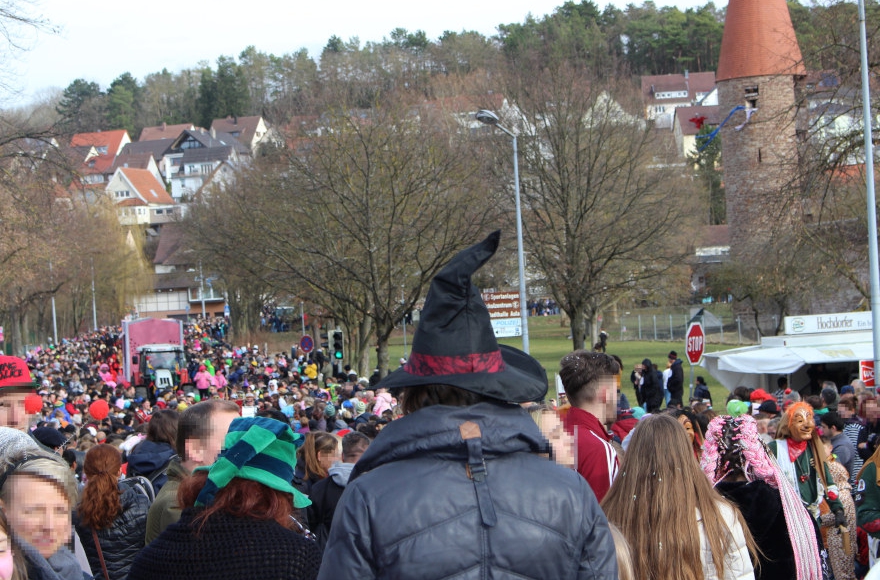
[503,64,701,349]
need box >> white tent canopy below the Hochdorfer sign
[700,331,874,392]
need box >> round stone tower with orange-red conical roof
[716,0,806,258]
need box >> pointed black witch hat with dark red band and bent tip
[377,231,547,403]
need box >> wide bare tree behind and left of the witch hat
[193,89,496,374]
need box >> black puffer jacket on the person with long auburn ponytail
[74,488,150,580]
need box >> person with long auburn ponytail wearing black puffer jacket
[74,445,150,580]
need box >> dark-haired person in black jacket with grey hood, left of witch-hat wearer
[307,431,370,549]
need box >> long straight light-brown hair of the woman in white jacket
[602,414,757,580]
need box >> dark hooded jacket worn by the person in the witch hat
[318,402,617,580]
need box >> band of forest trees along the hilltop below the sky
[32,0,880,138]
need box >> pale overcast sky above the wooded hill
[0,0,727,106]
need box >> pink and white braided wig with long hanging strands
[700,415,822,580]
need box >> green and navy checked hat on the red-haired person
[193,417,312,508]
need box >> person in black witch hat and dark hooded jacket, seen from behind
[318,232,617,580]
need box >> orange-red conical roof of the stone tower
[715,0,806,81]
